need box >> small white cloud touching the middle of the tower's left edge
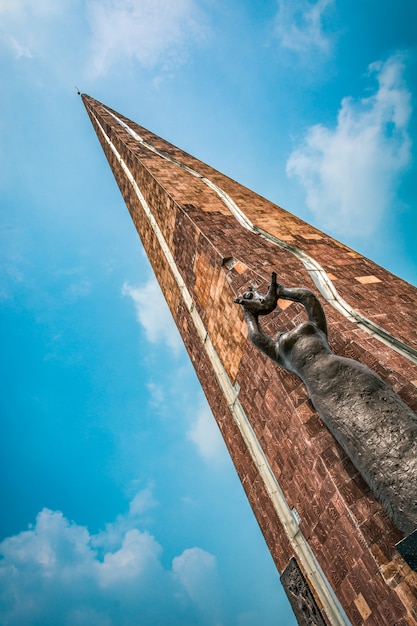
[122,278,182,352]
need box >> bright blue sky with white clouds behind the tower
[0,0,417,626]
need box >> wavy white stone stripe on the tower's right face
[106,109,417,363]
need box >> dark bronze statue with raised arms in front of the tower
[235,273,417,535]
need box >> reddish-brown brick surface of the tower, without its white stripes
[84,96,417,626]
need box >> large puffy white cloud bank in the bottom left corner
[0,492,221,626]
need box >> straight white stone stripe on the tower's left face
[91,112,350,626]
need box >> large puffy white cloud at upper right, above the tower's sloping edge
[287,55,411,236]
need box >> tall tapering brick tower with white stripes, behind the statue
[82,95,417,626]
